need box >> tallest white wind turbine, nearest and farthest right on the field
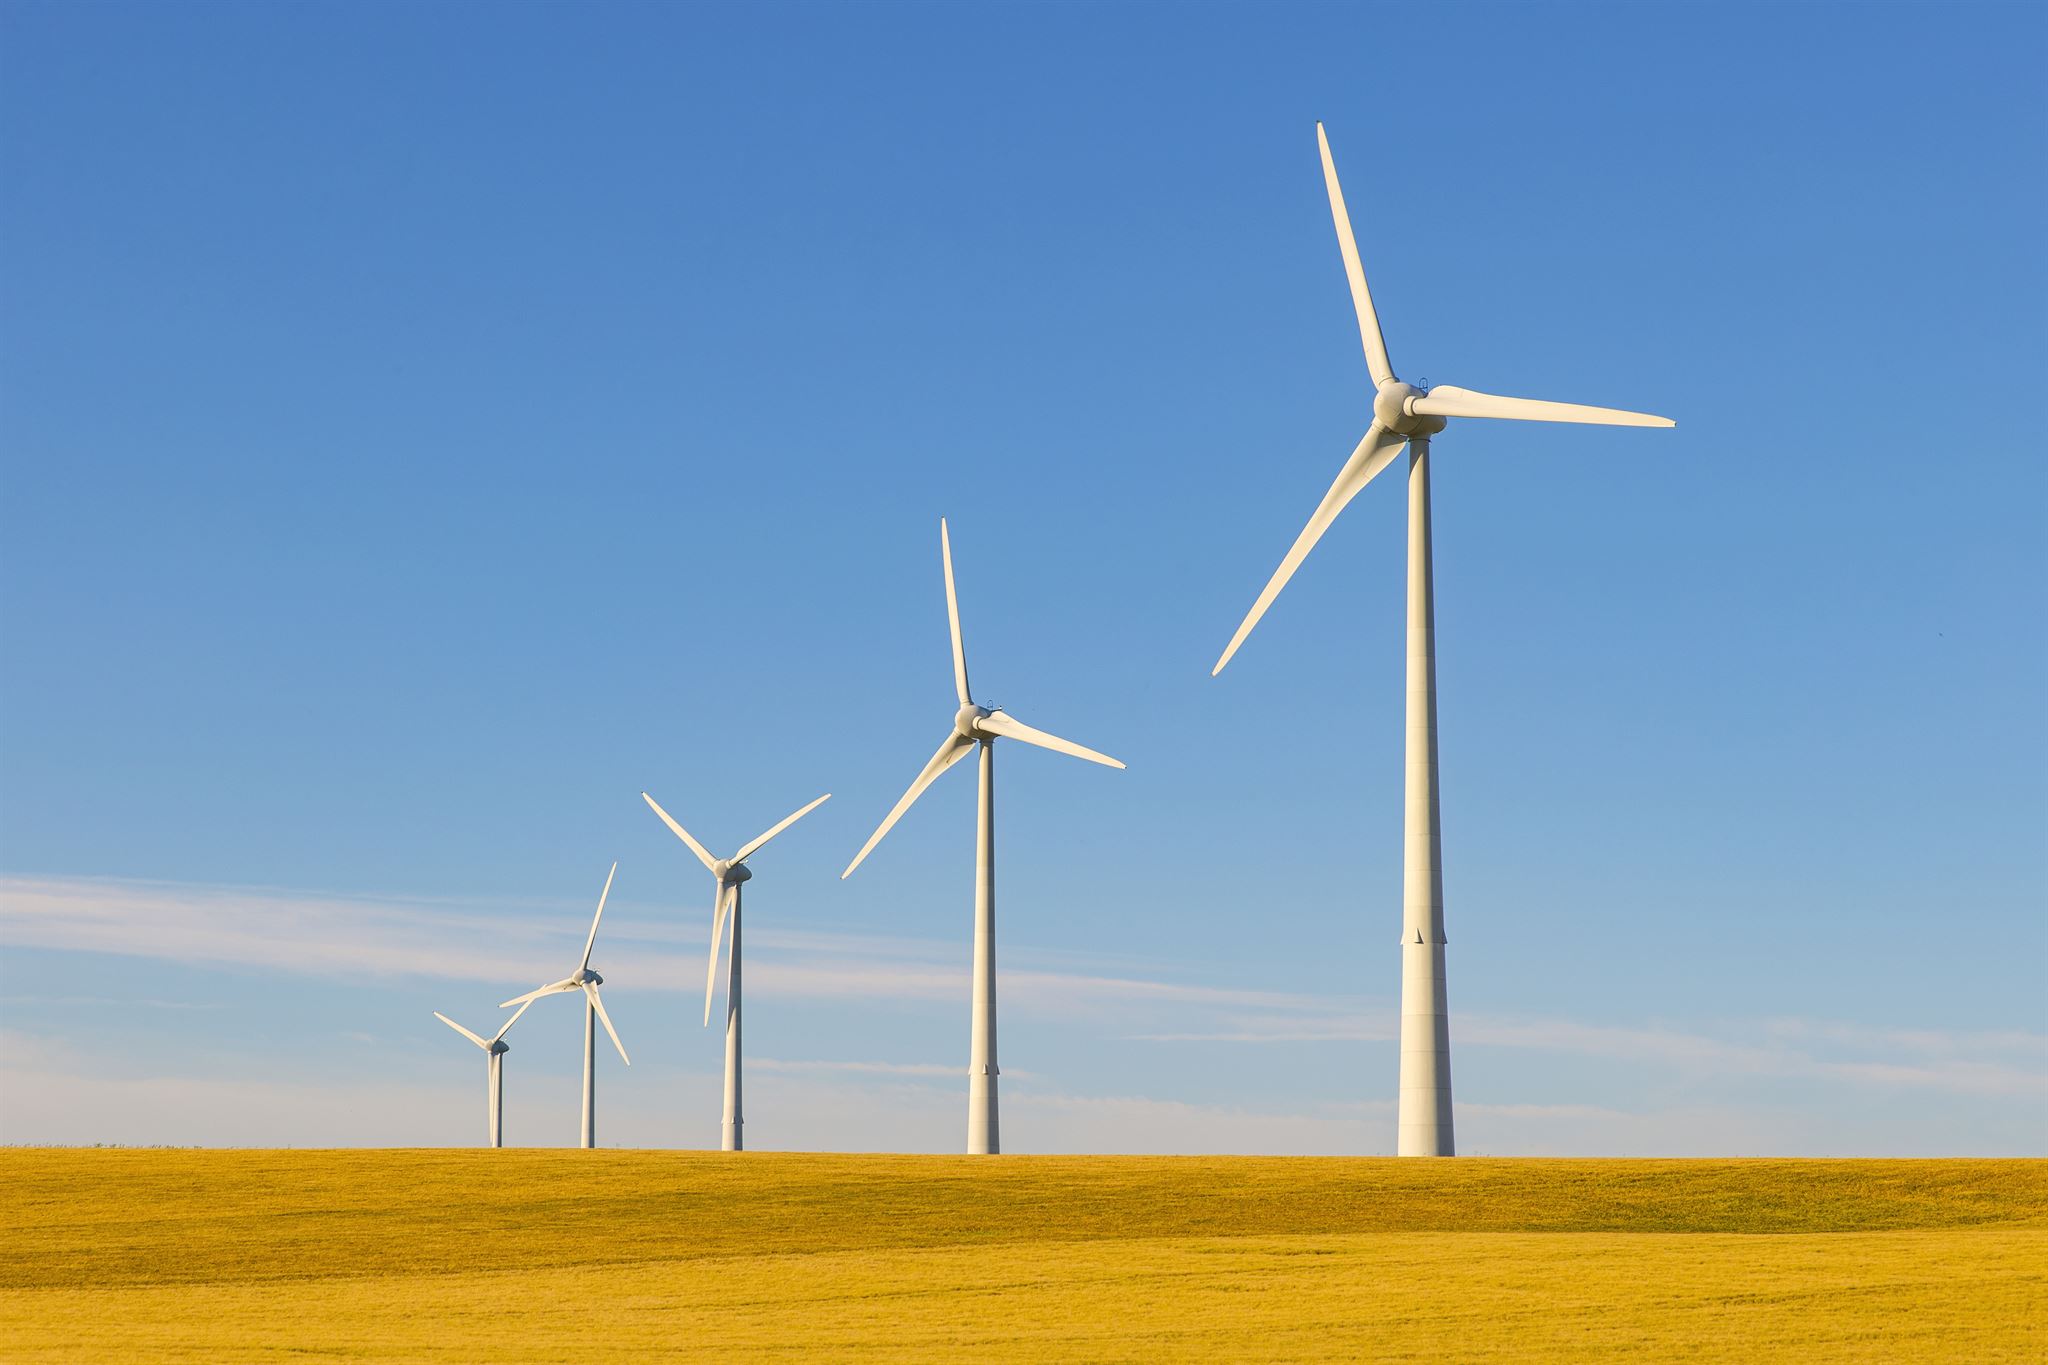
[1210,123,1677,1156]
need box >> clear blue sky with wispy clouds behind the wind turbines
[0,4,2048,1154]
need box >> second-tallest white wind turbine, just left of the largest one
[840,518,1122,1154]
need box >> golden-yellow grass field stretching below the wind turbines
[0,1148,2048,1365]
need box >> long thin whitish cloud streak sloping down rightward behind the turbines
[0,878,2048,1101]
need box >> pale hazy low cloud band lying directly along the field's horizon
[12,1033,1998,1156]
